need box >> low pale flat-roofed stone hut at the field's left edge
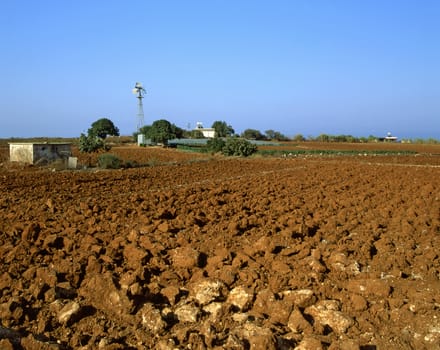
[9,142,72,164]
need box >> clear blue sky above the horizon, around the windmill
[0,0,440,139]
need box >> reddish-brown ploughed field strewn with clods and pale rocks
[0,146,440,350]
